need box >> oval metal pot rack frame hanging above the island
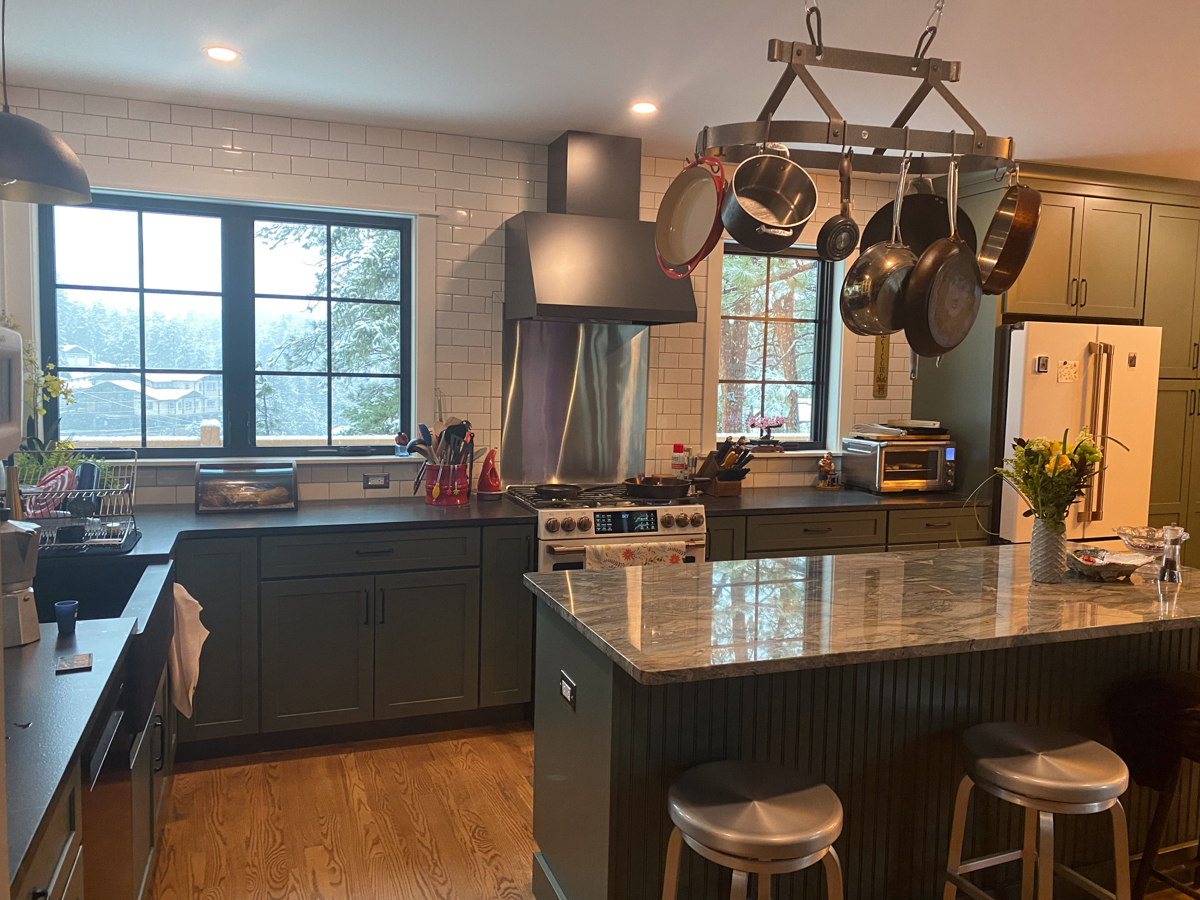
[696,38,1015,175]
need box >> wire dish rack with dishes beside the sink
[13,450,142,556]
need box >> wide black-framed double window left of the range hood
[40,194,412,456]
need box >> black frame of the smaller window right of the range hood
[716,241,835,451]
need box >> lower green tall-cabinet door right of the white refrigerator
[1150,382,1200,532]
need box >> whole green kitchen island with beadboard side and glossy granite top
[526,546,1200,900]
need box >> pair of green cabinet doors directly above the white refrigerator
[1004,192,1151,319]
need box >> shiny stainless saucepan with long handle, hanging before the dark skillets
[839,156,917,337]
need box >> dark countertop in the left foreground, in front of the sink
[4,618,136,882]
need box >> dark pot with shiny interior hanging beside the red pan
[721,119,817,253]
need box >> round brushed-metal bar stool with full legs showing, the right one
[942,722,1129,900]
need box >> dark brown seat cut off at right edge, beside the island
[1108,672,1200,900]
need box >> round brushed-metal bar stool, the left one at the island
[662,761,841,900]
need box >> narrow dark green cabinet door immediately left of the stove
[479,526,538,707]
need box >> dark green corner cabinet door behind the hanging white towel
[175,538,258,740]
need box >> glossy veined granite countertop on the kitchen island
[526,545,1200,684]
